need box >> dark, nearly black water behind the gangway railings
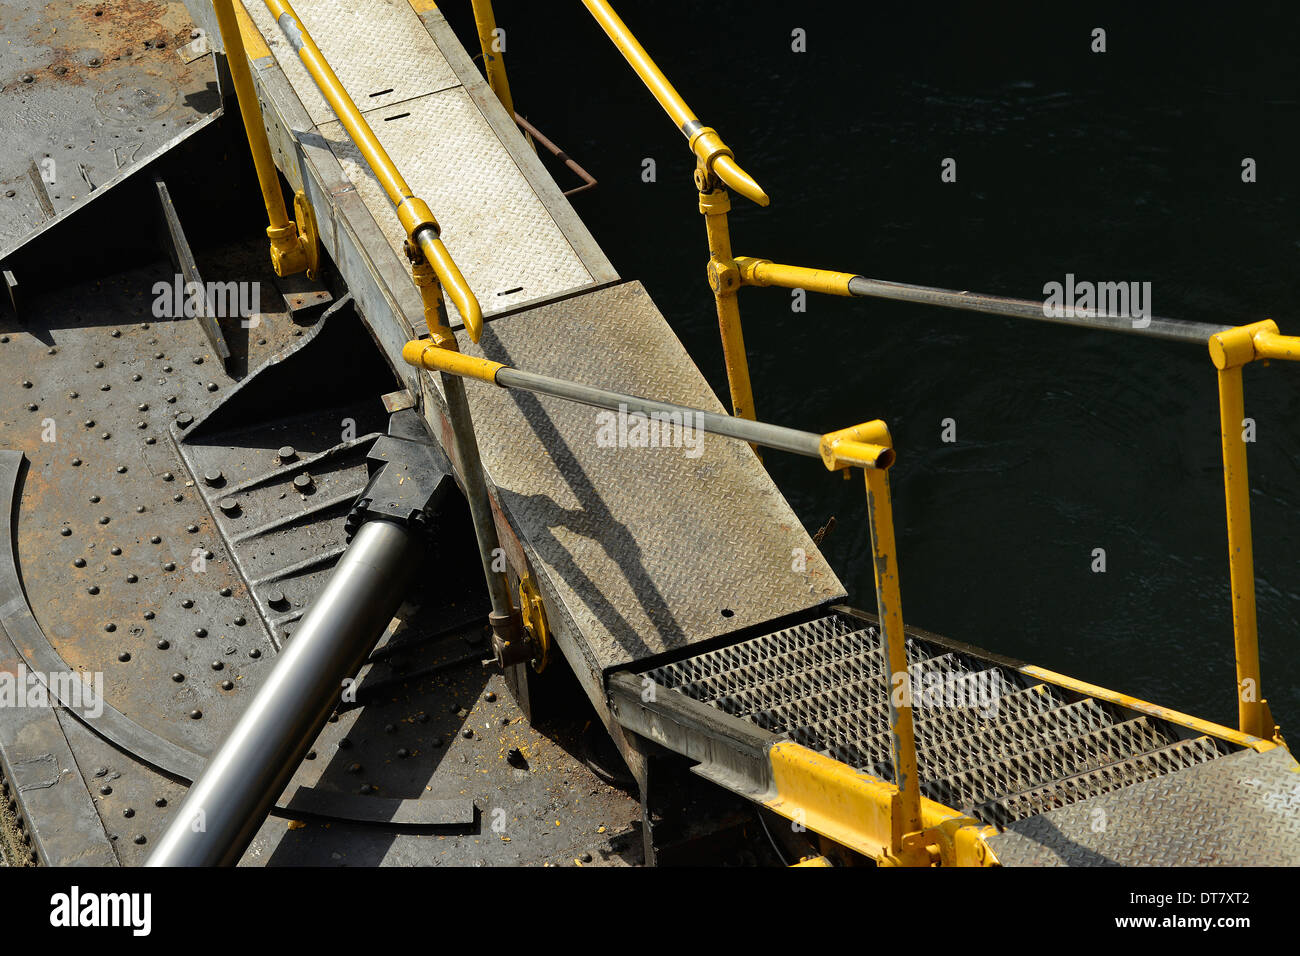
[447,0,1300,726]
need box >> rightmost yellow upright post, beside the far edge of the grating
[1218,365,1273,739]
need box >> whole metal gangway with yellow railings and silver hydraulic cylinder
[5,0,1300,866]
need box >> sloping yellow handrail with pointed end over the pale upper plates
[261,0,482,342]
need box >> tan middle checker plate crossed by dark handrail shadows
[460,282,844,669]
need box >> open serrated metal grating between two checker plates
[646,613,1229,826]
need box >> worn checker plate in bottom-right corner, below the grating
[988,747,1300,866]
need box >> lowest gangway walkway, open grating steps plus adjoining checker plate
[645,610,1300,865]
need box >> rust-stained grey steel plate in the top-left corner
[0,0,221,260]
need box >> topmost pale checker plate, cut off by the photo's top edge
[244,0,460,125]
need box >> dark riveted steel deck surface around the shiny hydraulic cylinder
[0,238,660,865]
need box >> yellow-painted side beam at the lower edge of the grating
[763,740,997,866]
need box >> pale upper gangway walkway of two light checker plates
[246,0,593,321]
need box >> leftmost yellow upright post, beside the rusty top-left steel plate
[212,0,315,276]
